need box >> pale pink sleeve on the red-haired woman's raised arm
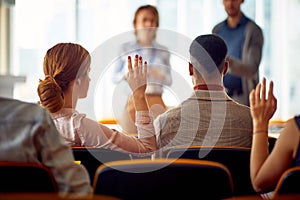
[75,111,157,154]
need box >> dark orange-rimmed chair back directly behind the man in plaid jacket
[167,146,256,196]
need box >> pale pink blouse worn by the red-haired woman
[52,108,157,153]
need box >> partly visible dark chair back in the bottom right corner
[274,166,300,198]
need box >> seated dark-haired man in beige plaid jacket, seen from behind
[154,34,252,157]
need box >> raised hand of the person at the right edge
[249,78,277,133]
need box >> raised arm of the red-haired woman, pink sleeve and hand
[88,55,157,153]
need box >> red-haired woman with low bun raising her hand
[38,43,156,154]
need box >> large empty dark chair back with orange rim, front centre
[93,159,233,199]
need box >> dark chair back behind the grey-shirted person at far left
[0,161,58,193]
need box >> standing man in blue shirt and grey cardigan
[212,0,263,106]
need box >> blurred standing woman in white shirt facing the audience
[113,5,172,134]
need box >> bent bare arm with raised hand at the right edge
[249,78,300,197]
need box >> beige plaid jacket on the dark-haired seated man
[153,90,252,158]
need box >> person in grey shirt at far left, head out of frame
[0,97,92,194]
